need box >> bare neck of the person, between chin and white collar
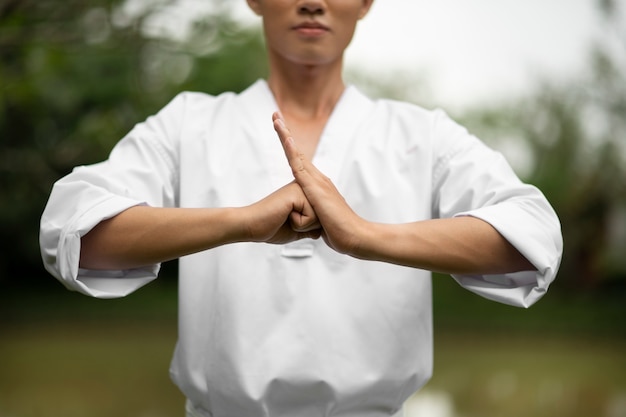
[268,57,345,121]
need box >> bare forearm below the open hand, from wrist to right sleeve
[351,217,535,274]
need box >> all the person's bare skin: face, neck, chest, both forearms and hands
[80,0,534,274]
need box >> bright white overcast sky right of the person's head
[230,0,620,108]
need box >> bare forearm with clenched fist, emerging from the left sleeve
[80,183,320,269]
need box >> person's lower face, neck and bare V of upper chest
[248,0,373,158]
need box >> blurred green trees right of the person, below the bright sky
[458,0,626,289]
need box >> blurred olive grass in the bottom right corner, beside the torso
[418,331,626,417]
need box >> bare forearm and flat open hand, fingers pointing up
[274,114,535,274]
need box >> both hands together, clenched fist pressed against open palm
[241,113,366,253]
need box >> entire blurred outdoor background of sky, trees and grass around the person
[0,0,626,417]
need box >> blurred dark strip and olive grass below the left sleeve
[0,277,184,417]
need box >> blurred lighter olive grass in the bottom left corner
[0,321,184,417]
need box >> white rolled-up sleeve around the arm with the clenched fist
[39,94,185,298]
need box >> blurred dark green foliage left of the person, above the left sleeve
[0,0,267,283]
